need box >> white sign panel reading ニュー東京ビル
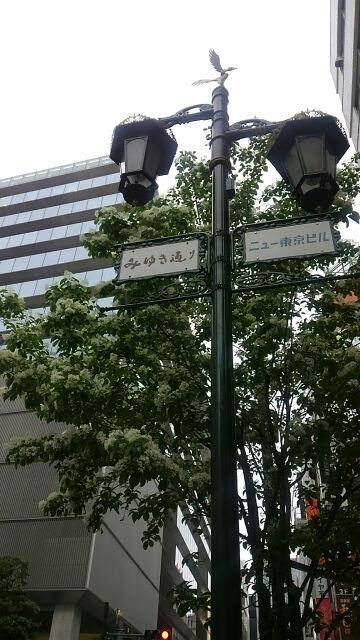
[244,220,337,264]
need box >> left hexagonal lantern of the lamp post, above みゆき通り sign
[110,119,177,207]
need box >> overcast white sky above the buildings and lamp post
[0,0,348,182]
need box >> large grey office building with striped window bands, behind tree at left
[0,157,210,640]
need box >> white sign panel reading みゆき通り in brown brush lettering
[116,238,201,282]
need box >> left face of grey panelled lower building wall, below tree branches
[0,399,91,606]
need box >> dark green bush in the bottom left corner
[0,556,39,640]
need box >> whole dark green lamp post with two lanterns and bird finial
[110,52,349,640]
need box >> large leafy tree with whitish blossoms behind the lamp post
[0,139,360,640]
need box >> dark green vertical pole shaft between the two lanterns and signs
[210,86,242,640]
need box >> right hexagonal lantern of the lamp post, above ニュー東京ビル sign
[267,116,349,214]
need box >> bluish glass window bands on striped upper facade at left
[0,157,123,306]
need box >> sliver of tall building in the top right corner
[330,0,360,151]
